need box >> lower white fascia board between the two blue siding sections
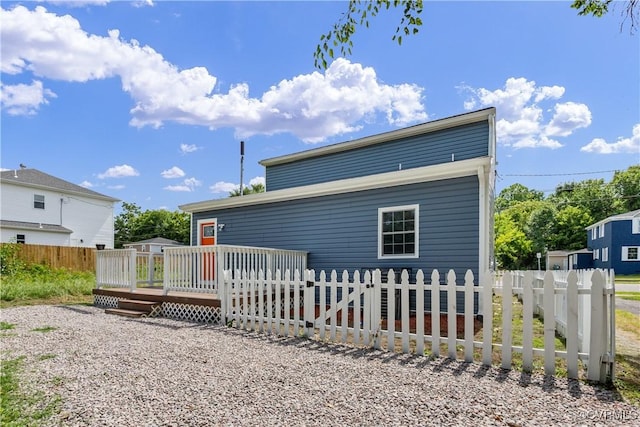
[178,157,492,213]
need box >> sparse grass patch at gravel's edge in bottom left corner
[0,356,61,427]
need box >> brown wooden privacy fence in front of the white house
[0,243,96,271]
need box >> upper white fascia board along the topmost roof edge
[259,107,496,167]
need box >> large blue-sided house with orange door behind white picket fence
[180,108,496,281]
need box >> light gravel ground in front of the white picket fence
[0,306,640,426]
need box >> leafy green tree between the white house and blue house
[114,202,191,248]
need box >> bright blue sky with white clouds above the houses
[0,0,640,210]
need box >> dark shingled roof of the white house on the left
[0,168,120,202]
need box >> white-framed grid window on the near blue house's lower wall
[378,205,420,258]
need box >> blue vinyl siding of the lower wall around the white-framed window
[192,176,479,280]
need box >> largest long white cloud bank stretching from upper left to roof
[0,6,427,142]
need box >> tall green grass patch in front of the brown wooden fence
[0,265,96,308]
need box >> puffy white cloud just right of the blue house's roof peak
[460,77,591,149]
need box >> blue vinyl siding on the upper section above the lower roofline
[266,121,489,191]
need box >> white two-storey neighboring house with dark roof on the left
[0,167,120,248]
